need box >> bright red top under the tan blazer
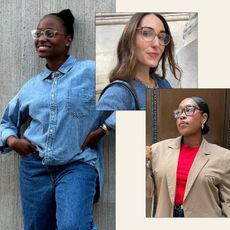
[175,144,199,205]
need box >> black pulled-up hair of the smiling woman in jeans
[48,9,74,39]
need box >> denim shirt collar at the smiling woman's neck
[41,55,77,80]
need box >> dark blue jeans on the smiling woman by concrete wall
[20,154,98,230]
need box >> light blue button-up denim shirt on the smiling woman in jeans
[0,56,103,198]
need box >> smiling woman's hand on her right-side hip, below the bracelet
[80,128,105,152]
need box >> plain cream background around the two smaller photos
[116,0,230,230]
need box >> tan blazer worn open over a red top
[146,137,230,217]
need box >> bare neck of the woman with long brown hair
[135,67,156,88]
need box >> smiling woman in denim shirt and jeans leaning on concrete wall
[0,10,102,230]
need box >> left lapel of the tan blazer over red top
[167,137,181,204]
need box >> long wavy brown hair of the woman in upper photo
[109,13,181,82]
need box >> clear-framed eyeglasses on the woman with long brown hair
[137,27,171,46]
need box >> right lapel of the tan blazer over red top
[184,138,209,201]
